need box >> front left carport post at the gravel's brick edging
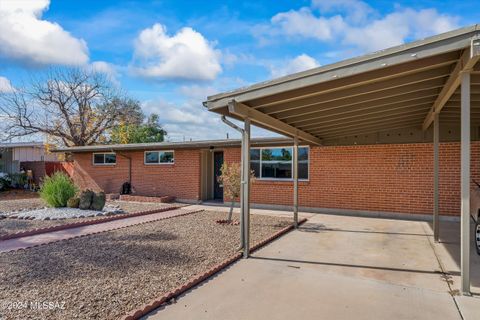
[242,118,250,258]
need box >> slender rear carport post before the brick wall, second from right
[433,112,440,242]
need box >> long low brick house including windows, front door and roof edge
[53,138,472,215]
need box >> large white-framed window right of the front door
[250,147,309,180]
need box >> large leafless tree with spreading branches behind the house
[0,69,143,146]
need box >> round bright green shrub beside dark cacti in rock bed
[40,172,77,208]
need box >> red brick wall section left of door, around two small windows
[73,150,200,200]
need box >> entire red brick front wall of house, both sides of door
[69,142,480,215]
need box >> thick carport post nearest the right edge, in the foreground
[460,71,470,295]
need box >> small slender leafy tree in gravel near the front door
[218,162,255,222]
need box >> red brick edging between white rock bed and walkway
[0,207,181,241]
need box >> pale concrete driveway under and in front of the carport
[147,214,480,320]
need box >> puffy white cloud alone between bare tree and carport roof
[132,23,222,80]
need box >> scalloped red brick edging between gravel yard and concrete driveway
[121,219,307,320]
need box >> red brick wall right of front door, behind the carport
[225,142,480,215]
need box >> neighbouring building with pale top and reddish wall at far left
[0,142,59,184]
